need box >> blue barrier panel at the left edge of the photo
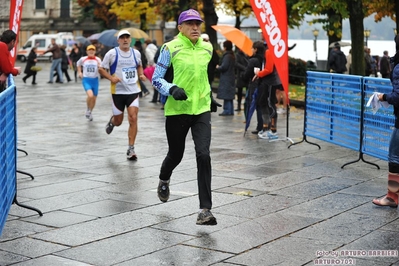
[0,76,17,235]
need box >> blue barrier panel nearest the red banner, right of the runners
[305,71,362,151]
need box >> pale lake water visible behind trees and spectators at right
[288,39,395,62]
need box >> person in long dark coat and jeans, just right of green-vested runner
[216,41,236,116]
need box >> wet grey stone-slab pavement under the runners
[0,62,399,266]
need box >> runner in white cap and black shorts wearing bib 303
[100,30,146,160]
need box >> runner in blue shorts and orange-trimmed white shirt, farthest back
[76,45,101,121]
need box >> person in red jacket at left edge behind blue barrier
[0,30,21,92]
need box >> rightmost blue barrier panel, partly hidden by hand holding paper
[362,77,395,161]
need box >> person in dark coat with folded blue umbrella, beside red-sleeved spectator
[242,41,265,134]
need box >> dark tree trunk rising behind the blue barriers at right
[348,0,365,76]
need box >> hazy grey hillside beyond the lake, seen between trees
[219,12,395,41]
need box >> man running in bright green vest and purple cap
[152,9,221,225]
